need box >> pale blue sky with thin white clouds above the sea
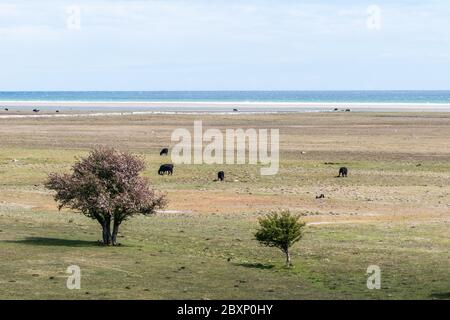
[0,0,450,91]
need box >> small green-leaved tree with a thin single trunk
[255,210,305,267]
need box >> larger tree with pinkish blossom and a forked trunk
[45,148,166,246]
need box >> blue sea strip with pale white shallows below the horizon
[0,90,450,112]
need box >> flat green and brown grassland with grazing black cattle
[0,113,450,299]
